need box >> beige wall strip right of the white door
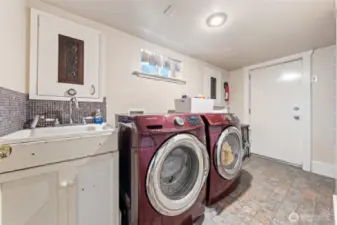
[312,46,337,164]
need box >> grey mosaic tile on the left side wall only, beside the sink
[0,87,28,136]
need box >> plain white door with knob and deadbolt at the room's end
[250,60,306,165]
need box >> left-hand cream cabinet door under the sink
[0,169,61,225]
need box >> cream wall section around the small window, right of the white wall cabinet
[103,29,227,118]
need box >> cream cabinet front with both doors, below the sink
[0,152,119,225]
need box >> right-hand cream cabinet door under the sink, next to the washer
[68,152,119,225]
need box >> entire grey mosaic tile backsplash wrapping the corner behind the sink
[0,87,107,136]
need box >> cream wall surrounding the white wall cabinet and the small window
[0,0,228,123]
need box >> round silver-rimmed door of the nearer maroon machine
[146,134,209,216]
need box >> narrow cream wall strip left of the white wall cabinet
[0,0,28,92]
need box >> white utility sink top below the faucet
[0,123,115,144]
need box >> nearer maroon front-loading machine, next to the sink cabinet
[118,114,209,225]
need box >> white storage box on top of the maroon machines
[174,98,214,113]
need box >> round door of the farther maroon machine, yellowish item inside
[214,127,243,180]
